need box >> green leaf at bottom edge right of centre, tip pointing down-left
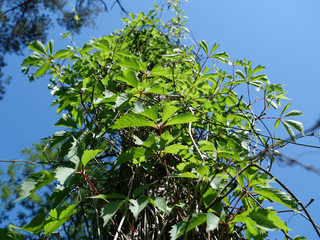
[170,213,207,240]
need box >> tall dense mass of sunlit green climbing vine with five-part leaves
[0,1,319,240]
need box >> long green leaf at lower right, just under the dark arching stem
[254,186,298,210]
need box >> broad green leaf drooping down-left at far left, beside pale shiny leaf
[15,170,56,202]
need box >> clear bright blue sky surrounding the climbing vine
[0,0,320,239]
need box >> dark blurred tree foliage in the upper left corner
[0,0,126,99]
